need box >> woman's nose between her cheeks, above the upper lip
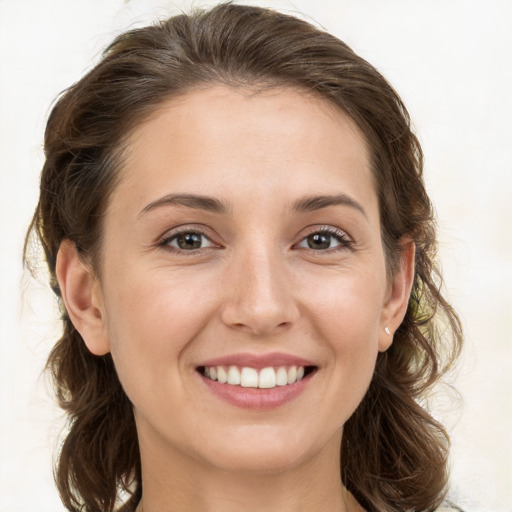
[221,250,299,336]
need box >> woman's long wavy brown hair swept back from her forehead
[27,3,462,512]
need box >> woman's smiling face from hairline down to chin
[86,86,402,471]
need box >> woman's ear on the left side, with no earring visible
[55,240,110,356]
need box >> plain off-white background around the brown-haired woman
[0,0,512,512]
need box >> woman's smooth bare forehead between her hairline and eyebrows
[112,86,375,218]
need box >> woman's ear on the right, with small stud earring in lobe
[379,238,416,352]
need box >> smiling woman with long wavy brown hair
[24,4,461,512]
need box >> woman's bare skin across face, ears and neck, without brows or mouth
[57,86,414,512]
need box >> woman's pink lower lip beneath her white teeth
[199,372,316,410]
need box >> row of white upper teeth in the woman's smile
[204,365,304,389]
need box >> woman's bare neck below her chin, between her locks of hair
[137,428,362,512]
